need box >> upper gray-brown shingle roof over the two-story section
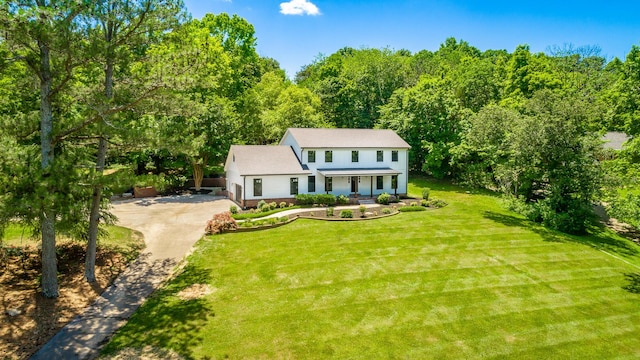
[285,128,411,149]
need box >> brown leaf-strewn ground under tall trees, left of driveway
[0,228,144,359]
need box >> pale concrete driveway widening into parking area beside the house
[31,195,233,360]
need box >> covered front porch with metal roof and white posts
[317,168,400,198]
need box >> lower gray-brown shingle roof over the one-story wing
[229,145,310,175]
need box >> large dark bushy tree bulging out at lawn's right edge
[454,90,601,233]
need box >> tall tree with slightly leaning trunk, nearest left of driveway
[84,0,182,282]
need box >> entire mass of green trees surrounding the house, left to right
[0,0,640,297]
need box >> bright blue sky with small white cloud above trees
[185,0,640,78]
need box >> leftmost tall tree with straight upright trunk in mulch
[0,0,86,298]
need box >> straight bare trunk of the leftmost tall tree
[38,37,59,298]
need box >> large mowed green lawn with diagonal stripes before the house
[104,180,640,359]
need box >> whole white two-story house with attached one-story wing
[225,128,410,207]
